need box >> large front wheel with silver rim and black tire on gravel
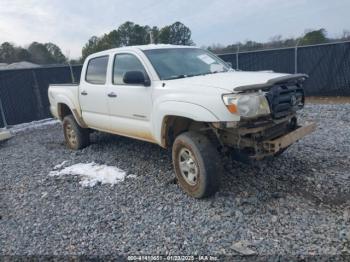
[172,132,222,198]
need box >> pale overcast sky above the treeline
[0,0,350,58]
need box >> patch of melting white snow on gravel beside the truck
[49,162,129,187]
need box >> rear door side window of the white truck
[85,56,108,85]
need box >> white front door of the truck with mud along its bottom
[108,52,154,141]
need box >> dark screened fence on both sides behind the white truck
[0,42,350,127]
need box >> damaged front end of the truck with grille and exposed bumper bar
[213,74,316,160]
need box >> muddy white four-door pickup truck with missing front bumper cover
[48,45,315,198]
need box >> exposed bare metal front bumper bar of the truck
[263,123,316,154]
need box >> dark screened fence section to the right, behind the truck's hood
[219,42,350,96]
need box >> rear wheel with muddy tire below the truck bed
[63,115,90,150]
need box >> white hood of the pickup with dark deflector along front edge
[163,71,307,92]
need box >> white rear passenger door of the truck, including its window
[79,55,110,131]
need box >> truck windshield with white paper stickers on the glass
[143,48,230,80]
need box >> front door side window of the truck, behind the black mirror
[113,54,147,85]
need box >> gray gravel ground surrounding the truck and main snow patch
[0,104,350,256]
